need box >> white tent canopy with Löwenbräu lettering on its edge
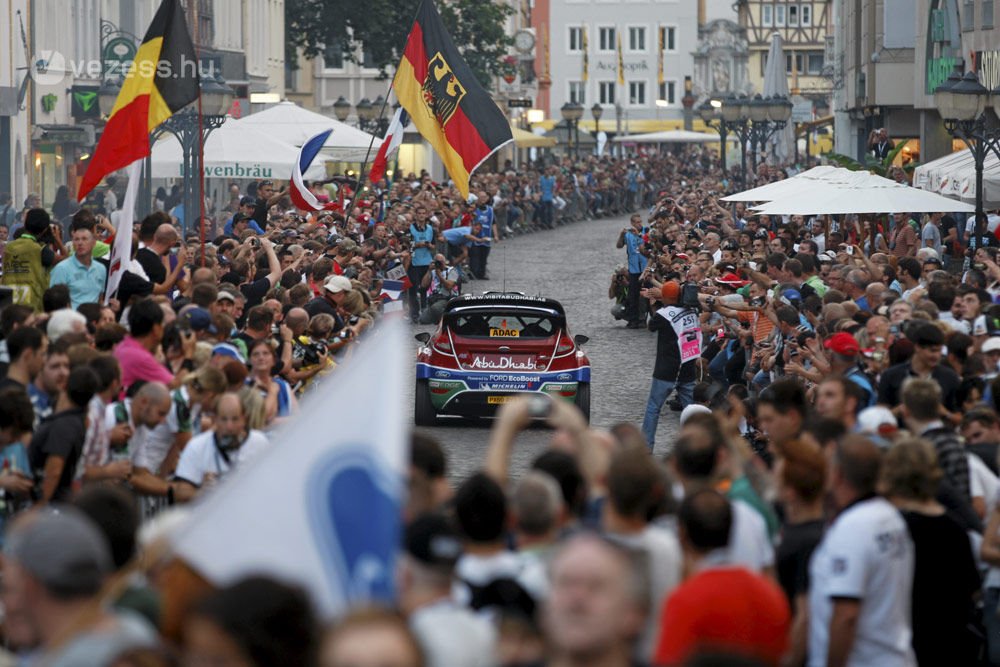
[152,120,326,179]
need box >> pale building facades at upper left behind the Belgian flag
[23,0,285,206]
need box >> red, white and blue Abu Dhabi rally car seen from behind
[413,292,590,426]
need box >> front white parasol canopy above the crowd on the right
[755,171,975,215]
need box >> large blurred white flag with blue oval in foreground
[173,322,408,618]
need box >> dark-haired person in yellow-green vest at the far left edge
[0,208,63,312]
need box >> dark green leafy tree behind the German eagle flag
[285,0,512,89]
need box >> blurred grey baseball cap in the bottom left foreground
[4,505,113,597]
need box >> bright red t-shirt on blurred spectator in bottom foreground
[653,567,791,665]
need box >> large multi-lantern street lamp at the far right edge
[934,68,1000,247]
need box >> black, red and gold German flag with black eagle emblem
[392,0,514,198]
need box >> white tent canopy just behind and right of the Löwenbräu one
[233,102,382,162]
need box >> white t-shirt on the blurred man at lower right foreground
[809,498,917,667]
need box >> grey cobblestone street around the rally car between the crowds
[406,216,677,479]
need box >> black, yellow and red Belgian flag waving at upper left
[77,0,199,200]
